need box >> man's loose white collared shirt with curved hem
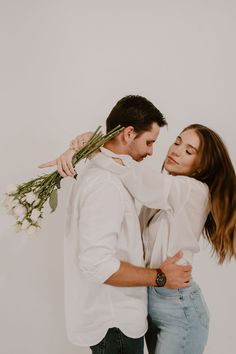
[64,149,147,346]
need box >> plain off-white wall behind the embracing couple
[0,0,236,354]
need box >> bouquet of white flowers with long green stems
[3,126,124,234]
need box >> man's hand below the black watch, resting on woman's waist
[160,251,192,289]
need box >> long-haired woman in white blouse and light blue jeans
[39,124,236,354]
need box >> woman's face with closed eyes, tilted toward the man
[164,129,200,176]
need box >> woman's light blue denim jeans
[146,282,209,354]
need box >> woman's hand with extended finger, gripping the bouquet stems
[39,148,76,177]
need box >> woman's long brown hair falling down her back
[183,124,236,264]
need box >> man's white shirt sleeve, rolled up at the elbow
[78,173,124,283]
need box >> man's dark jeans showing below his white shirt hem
[90,327,144,354]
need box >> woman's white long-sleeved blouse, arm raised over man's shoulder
[120,163,209,268]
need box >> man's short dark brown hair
[106,95,167,134]
